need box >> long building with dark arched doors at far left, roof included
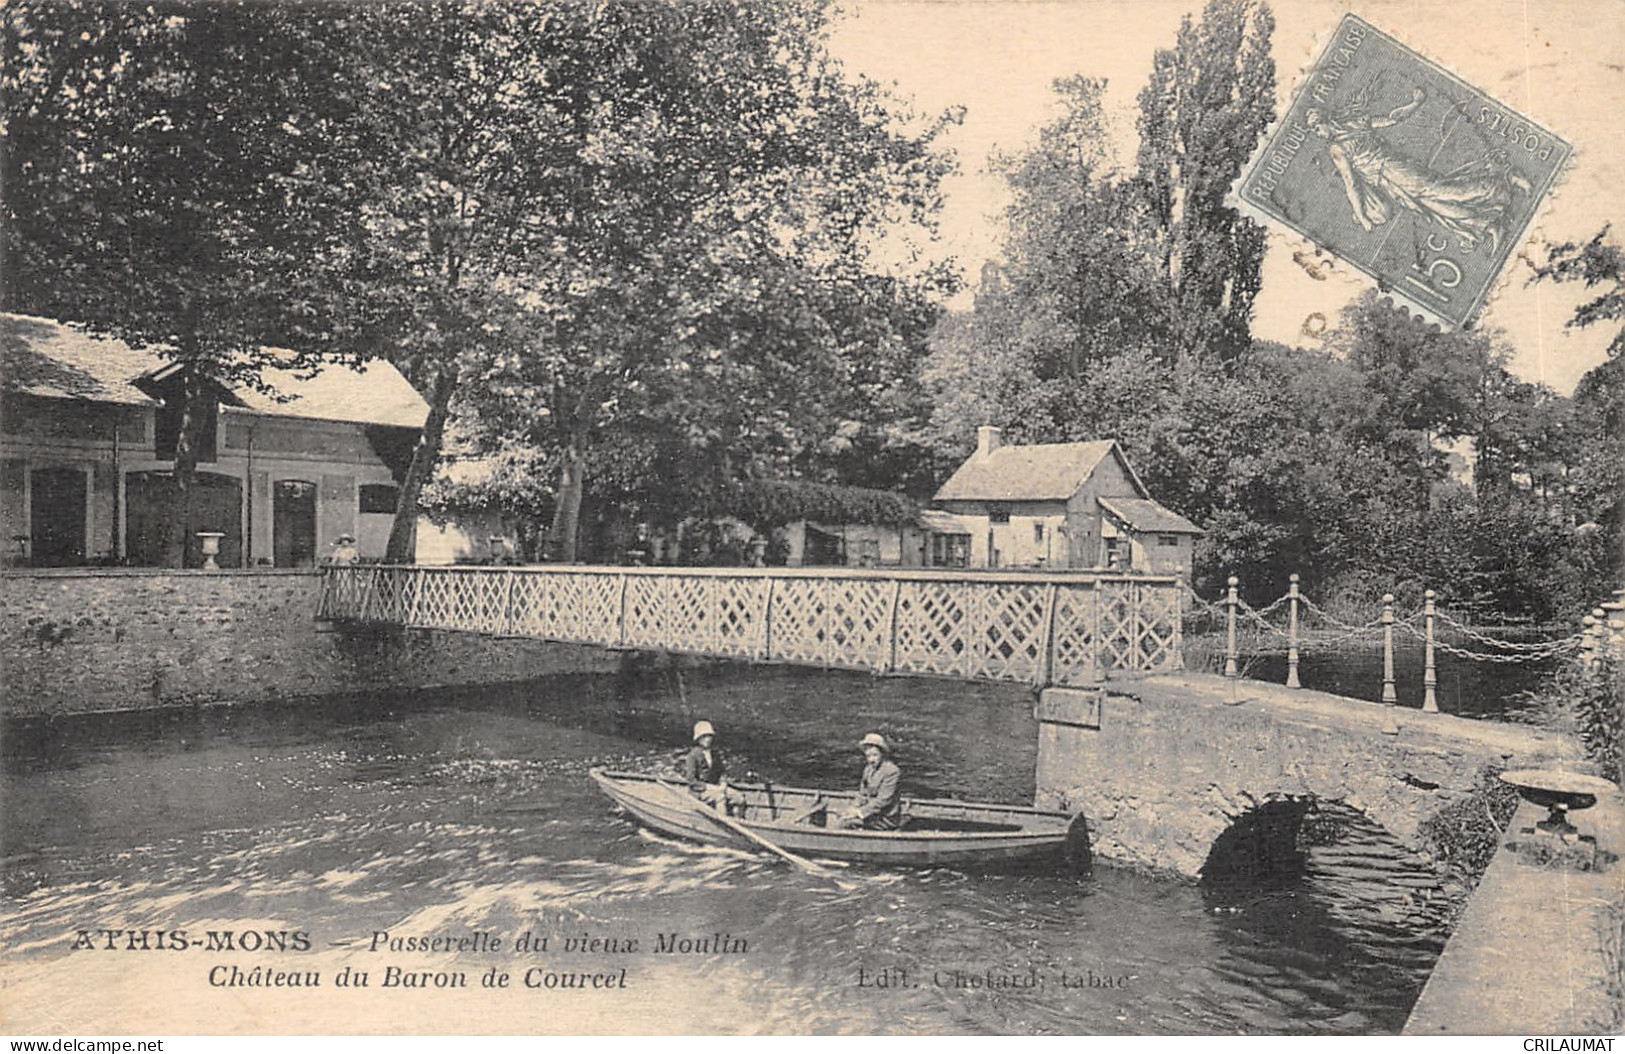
[0,313,427,567]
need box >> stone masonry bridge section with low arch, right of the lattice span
[1037,674,1580,879]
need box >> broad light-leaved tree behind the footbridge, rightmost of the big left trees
[458,0,951,560]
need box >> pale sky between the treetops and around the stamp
[832,0,1625,395]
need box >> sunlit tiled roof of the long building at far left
[0,313,429,429]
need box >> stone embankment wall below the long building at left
[0,568,618,716]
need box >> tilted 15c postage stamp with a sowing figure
[1233,15,1573,328]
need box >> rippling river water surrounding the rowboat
[0,666,1443,1035]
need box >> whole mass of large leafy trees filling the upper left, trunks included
[5,0,954,560]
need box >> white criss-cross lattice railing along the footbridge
[320,565,1183,685]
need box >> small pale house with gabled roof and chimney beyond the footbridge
[928,427,1203,575]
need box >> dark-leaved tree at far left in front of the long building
[0,0,372,565]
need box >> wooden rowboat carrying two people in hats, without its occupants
[588,768,1089,867]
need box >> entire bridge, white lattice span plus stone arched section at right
[310,565,1580,877]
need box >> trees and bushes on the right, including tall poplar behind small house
[923,2,1625,619]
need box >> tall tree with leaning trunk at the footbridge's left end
[302,0,588,562]
